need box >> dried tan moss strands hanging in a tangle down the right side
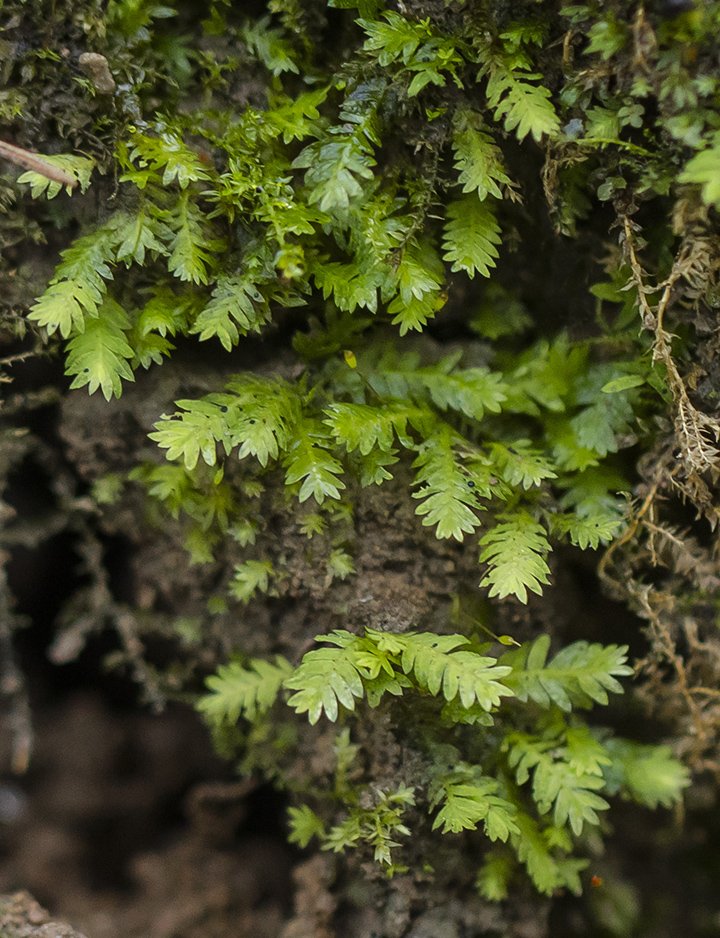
[599,216,720,771]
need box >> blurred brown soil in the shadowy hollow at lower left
[0,693,292,938]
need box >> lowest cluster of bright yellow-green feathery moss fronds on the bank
[195,629,688,899]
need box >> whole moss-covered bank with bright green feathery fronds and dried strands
[0,0,720,932]
